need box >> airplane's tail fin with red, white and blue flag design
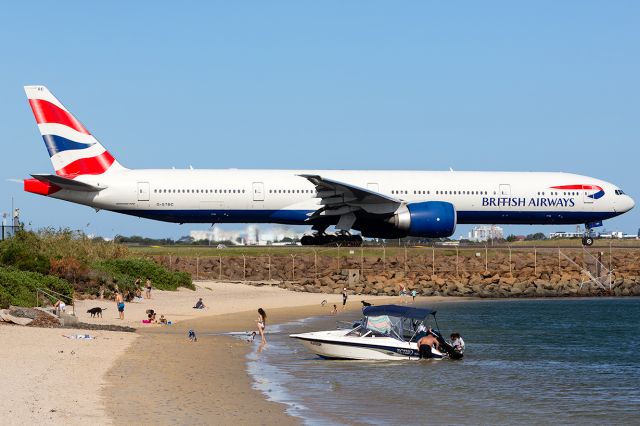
[24,86,124,179]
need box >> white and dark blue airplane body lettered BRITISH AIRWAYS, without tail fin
[46,169,634,228]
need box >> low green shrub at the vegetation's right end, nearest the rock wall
[92,259,195,290]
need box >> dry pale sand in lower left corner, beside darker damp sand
[0,325,138,425]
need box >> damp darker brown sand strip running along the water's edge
[104,286,450,425]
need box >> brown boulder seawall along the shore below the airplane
[154,249,640,298]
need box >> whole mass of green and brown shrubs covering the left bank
[0,228,195,306]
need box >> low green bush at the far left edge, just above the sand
[0,267,73,308]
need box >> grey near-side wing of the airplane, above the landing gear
[299,175,402,226]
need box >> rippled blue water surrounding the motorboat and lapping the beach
[248,298,640,425]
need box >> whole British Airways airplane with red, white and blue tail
[24,86,634,245]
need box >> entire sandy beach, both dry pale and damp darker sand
[0,282,456,425]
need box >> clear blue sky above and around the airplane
[0,1,640,237]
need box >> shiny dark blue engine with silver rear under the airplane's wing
[389,201,457,238]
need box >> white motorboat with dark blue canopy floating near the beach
[289,305,450,360]
